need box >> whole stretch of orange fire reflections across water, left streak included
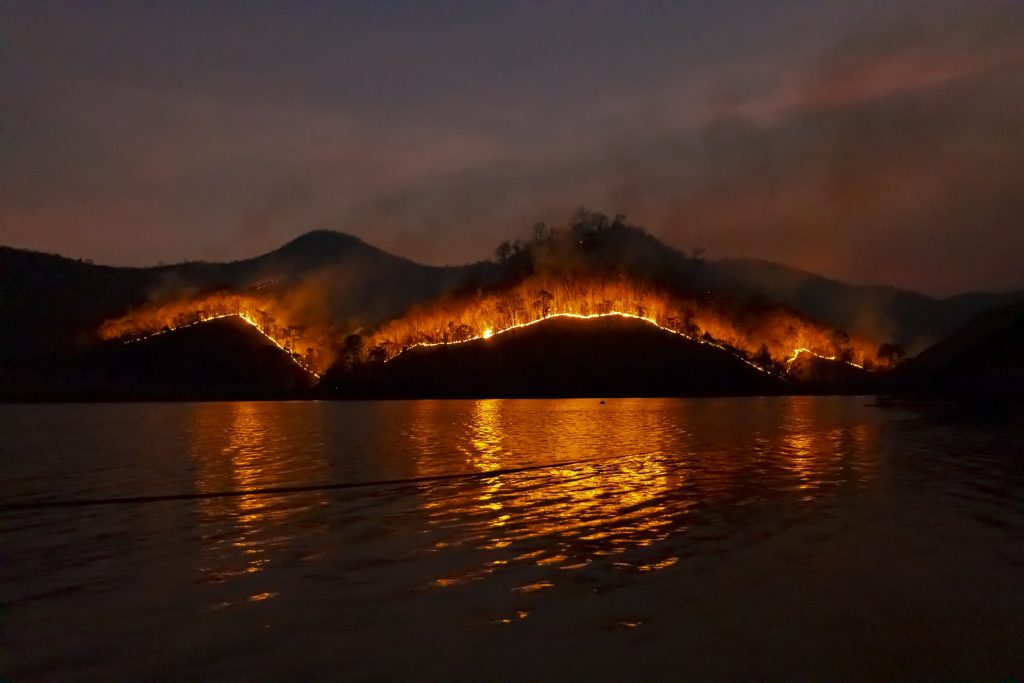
[176,398,878,604]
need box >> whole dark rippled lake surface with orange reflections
[0,398,1024,681]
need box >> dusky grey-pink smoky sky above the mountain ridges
[0,0,1024,296]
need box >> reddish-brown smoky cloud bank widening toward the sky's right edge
[331,3,1024,294]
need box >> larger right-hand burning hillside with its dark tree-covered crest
[354,211,895,375]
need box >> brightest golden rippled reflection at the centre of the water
[414,399,683,592]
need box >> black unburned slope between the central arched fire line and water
[319,317,794,398]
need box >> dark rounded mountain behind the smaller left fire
[0,230,487,362]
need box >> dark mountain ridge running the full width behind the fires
[0,223,1021,369]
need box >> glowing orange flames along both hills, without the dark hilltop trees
[99,274,886,378]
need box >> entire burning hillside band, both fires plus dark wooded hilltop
[99,210,900,385]
